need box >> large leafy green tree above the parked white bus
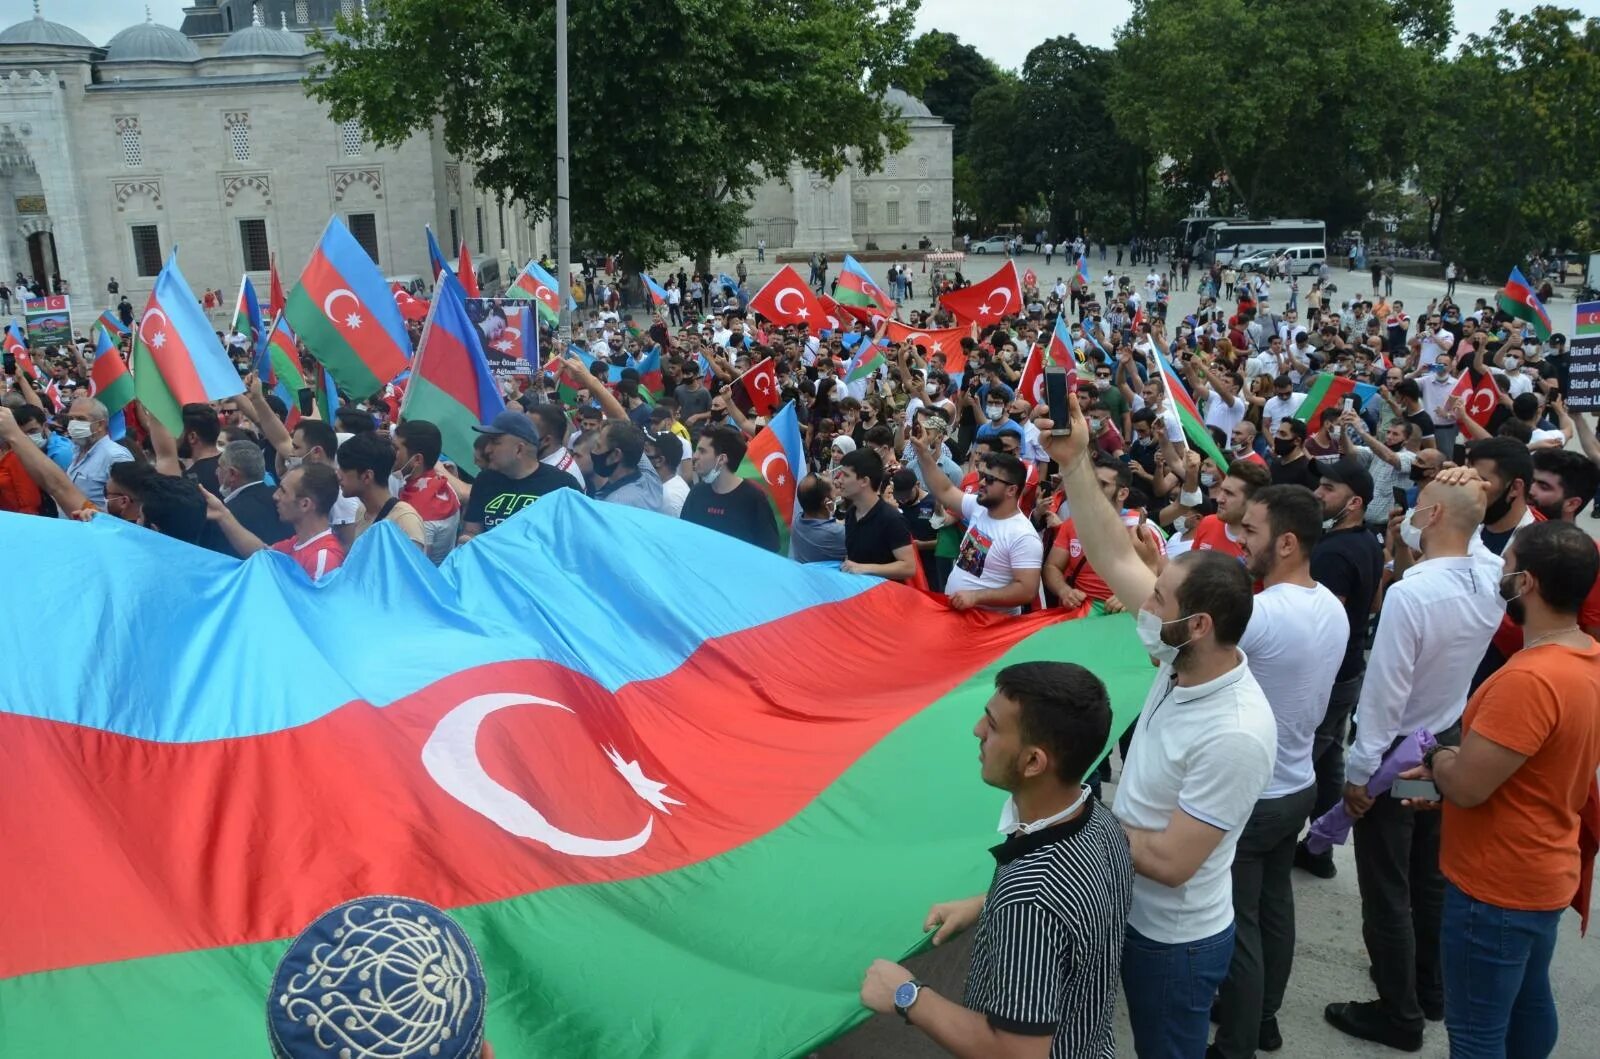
[1110,0,1437,226]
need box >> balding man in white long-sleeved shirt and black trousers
[1323,480,1506,1051]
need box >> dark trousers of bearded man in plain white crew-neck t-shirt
[1216,784,1317,1059]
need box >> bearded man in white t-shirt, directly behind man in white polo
[1214,485,1350,1059]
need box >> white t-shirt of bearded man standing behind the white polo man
[1238,584,1350,798]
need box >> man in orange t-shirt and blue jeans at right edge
[1406,522,1600,1056]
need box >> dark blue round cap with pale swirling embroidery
[267,896,494,1059]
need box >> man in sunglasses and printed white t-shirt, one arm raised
[912,430,1045,614]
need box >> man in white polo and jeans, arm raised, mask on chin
[1040,397,1273,1057]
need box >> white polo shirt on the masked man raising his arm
[1112,651,1277,945]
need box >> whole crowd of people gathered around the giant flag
[0,257,1600,1059]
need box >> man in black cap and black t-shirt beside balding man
[1294,456,1384,878]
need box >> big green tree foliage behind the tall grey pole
[307,0,926,267]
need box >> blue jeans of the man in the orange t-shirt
[1440,881,1562,1059]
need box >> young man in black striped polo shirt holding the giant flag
[861,662,1133,1059]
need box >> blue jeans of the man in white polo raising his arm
[1122,923,1234,1059]
